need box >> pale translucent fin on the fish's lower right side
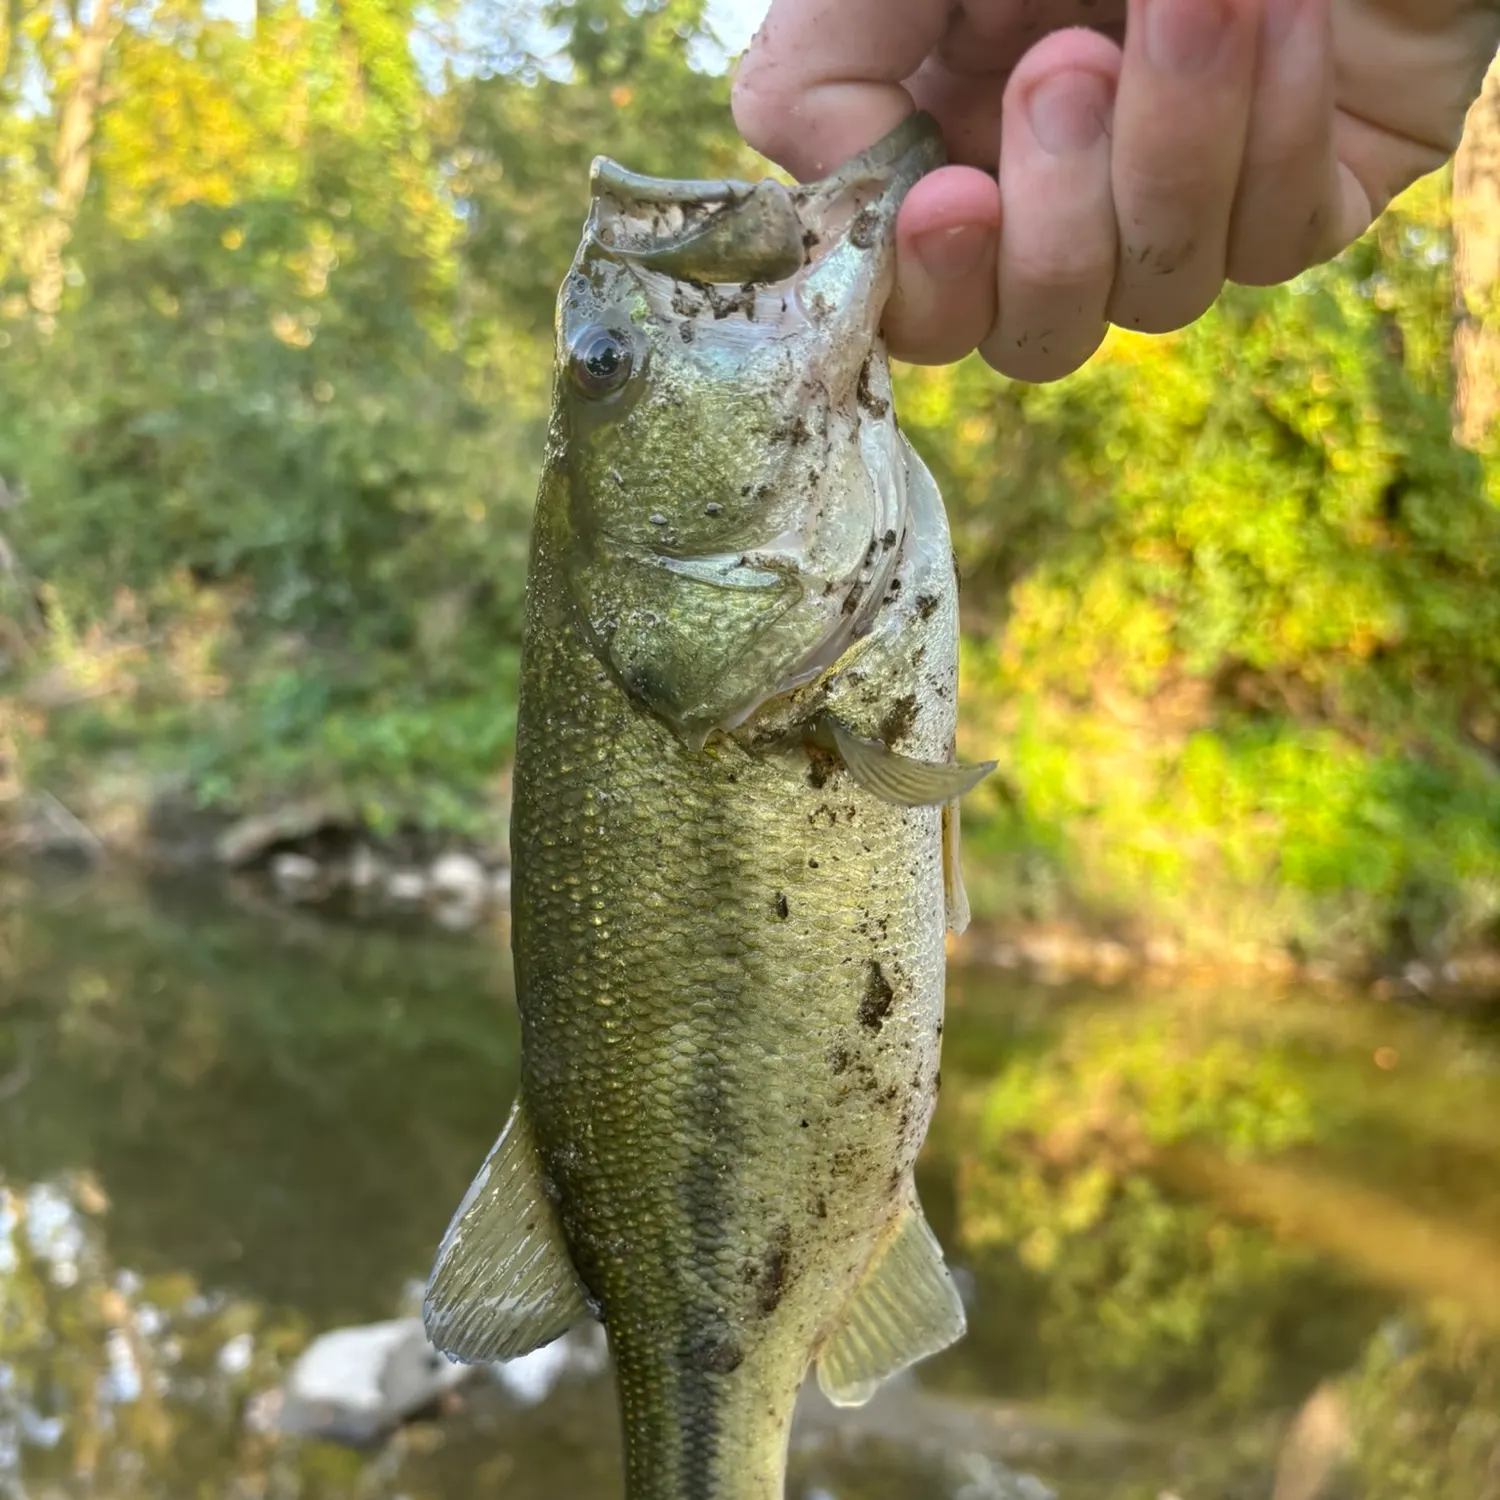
[818,1197,965,1406]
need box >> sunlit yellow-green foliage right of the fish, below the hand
[902,170,1500,954]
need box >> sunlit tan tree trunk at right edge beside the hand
[1454,48,1500,449]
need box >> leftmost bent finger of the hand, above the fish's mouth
[734,0,951,182]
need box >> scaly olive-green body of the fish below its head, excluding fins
[513,585,942,1500]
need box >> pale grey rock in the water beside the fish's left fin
[276,1317,474,1446]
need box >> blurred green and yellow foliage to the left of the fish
[0,3,743,833]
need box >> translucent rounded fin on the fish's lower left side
[422,1100,590,1365]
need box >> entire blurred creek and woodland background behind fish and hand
[0,0,1500,1500]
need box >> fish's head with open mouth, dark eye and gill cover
[554,116,942,744]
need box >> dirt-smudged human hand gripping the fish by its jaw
[734,0,1500,381]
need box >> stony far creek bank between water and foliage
[0,756,1500,1008]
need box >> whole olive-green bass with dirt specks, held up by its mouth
[423,116,993,1500]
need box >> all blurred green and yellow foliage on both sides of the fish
[0,0,1500,959]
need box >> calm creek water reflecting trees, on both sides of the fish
[0,875,1500,1500]
